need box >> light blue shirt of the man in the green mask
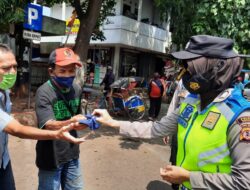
[0,91,12,169]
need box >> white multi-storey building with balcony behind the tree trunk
[41,0,170,78]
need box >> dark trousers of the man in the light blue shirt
[0,162,16,190]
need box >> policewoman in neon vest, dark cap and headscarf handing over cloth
[93,35,250,190]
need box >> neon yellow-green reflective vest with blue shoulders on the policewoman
[177,91,249,189]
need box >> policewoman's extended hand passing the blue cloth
[92,109,119,127]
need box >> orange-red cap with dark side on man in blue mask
[49,48,82,67]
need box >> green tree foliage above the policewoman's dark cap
[155,0,250,54]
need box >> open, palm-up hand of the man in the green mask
[56,123,85,144]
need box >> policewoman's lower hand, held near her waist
[160,165,190,184]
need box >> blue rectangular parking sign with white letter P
[23,3,43,31]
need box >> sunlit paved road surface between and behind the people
[9,100,174,190]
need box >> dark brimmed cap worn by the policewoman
[171,35,239,59]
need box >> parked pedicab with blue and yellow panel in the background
[81,77,146,121]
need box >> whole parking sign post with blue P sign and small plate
[23,3,43,109]
